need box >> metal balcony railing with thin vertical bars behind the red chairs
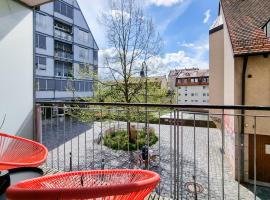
[34,102,270,199]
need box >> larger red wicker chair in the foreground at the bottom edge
[6,170,160,200]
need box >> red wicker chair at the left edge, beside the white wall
[0,133,48,171]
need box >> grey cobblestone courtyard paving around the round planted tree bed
[43,120,267,200]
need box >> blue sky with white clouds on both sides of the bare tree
[77,0,219,75]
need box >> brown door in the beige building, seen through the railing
[249,135,270,183]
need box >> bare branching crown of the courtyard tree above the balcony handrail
[101,0,162,103]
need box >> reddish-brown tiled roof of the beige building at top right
[221,0,270,55]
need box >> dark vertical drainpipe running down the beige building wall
[240,56,248,181]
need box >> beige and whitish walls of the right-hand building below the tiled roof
[209,3,270,184]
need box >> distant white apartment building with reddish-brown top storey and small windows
[175,68,209,105]
